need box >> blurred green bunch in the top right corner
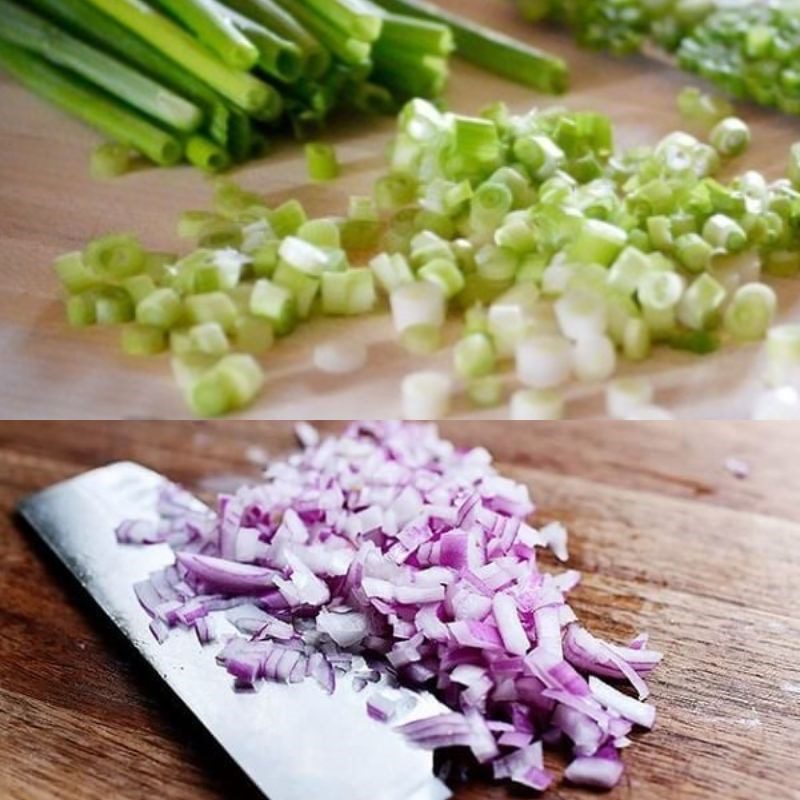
[516,0,800,119]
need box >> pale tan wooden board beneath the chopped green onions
[0,0,800,419]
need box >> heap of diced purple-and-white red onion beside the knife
[117,422,661,791]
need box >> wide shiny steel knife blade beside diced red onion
[18,462,451,800]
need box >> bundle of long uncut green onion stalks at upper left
[0,0,566,176]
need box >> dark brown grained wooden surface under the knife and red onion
[0,422,800,800]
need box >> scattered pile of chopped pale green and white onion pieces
[56,98,800,417]
